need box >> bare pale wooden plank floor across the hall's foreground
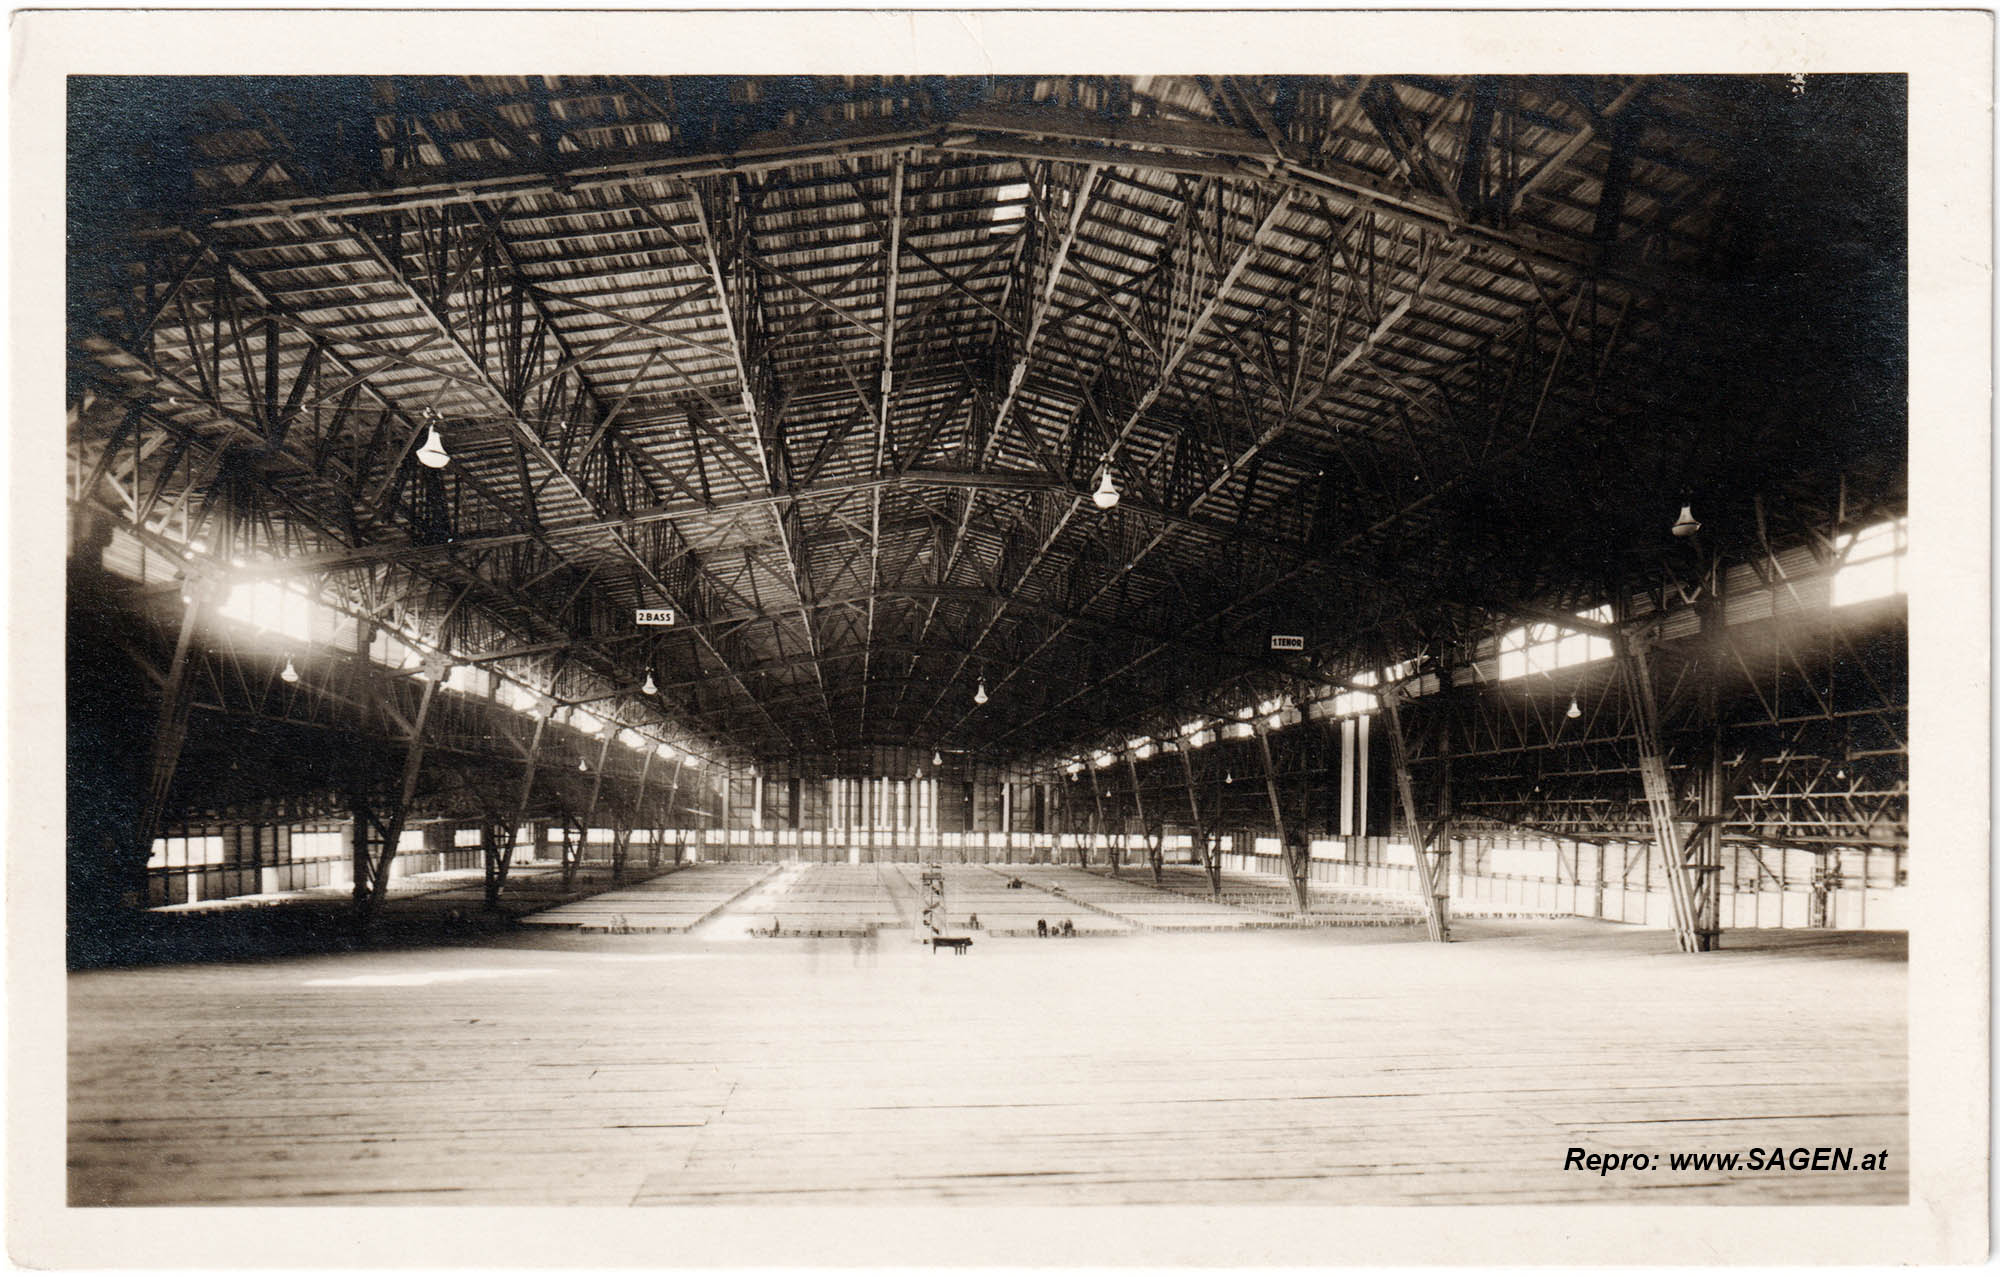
[68,921,1908,1205]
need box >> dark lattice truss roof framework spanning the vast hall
[68,76,1902,808]
